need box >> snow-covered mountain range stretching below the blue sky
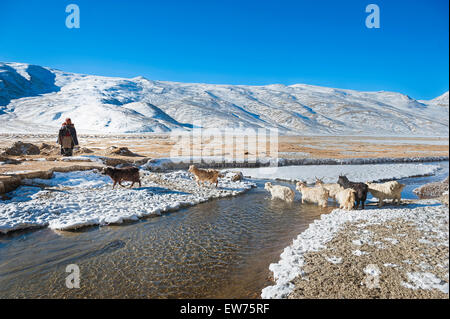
[0,62,449,136]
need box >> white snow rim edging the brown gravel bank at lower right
[261,201,448,298]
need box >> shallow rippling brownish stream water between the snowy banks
[0,162,448,298]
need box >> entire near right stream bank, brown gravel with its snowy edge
[262,200,449,298]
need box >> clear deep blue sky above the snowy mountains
[0,0,449,99]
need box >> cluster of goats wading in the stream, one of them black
[264,176,405,210]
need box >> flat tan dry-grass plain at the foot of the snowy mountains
[0,134,449,179]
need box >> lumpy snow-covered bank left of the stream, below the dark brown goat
[0,171,253,233]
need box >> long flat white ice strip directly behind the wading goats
[239,164,440,183]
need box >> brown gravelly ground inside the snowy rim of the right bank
[289,205,448,299]
